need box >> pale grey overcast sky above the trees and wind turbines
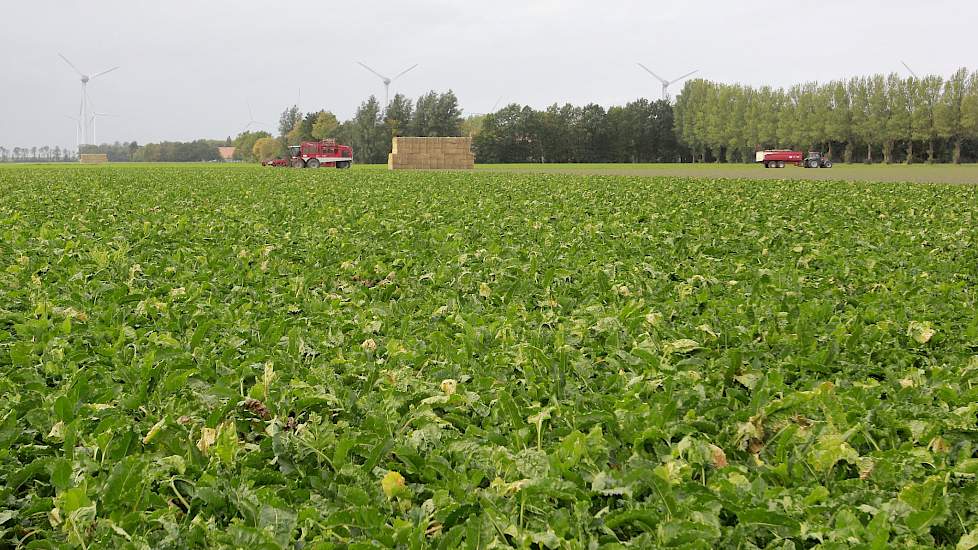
[0,0,978,147]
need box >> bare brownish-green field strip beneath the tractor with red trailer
[476,163,978,183]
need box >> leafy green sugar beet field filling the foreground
[0,166,978,549]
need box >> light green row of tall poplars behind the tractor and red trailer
[674,69,978,163]
